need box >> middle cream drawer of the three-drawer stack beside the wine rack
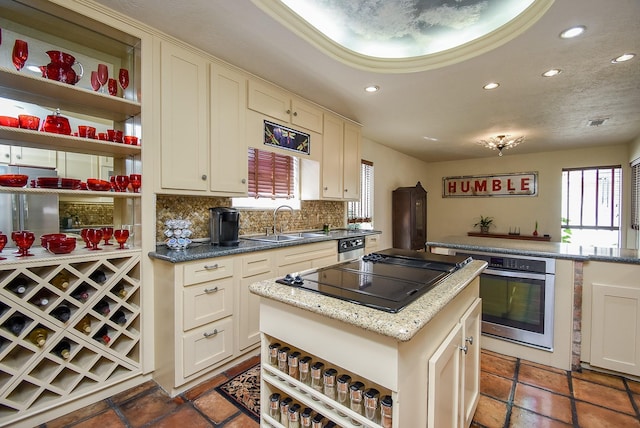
[182,278,233,331]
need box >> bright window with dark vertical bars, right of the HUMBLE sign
[561,165,622,247]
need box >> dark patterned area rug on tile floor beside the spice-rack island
[216,364,260,422]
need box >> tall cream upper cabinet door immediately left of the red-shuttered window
[210,65,247,196]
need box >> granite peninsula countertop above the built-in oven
[427,236,640,264]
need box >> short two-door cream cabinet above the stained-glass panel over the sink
[248,79,323,134]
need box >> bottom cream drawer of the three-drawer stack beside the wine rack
[182,317,234,378]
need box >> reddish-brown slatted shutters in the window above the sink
[248,147,297,199]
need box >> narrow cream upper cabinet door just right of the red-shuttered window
[322,114,344,199]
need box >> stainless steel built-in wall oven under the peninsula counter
[456,251,555,351]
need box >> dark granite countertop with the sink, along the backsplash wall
[149,229,382,263]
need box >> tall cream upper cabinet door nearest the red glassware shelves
[160,42,209,191]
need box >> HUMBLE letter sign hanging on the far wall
[442,172,538,198]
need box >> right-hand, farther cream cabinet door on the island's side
[460,299,482,427]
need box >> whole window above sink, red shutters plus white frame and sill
[232,147,300,209]
